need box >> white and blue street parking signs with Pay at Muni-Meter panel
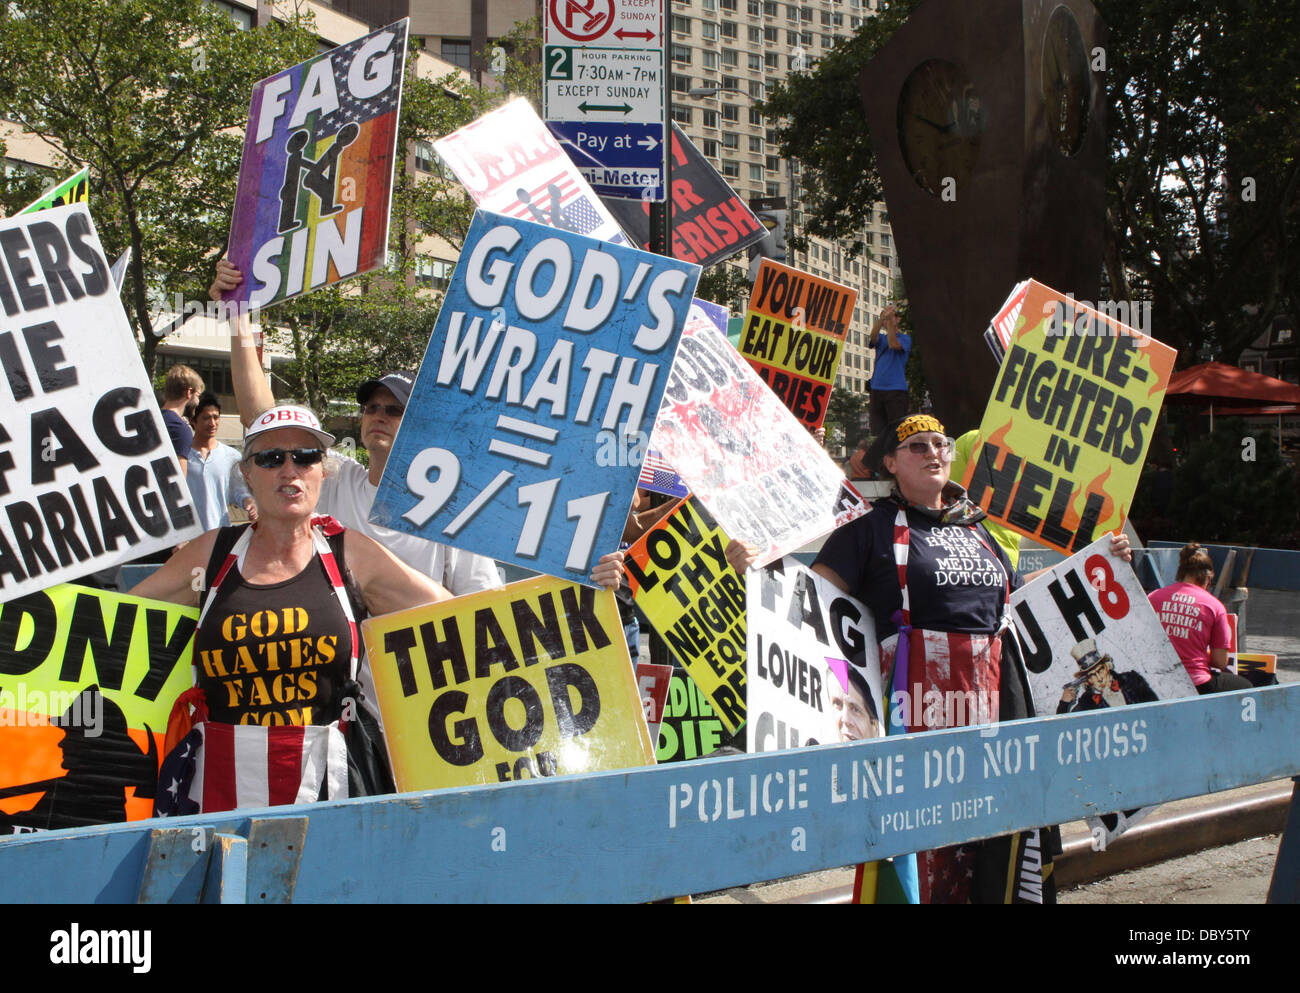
[542,0,667,201]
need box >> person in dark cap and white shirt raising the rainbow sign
[209,259,501,597]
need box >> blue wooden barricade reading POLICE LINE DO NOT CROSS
[0,684,1300,903]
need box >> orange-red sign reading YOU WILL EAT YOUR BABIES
[740,259,858,428]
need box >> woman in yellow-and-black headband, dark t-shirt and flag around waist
[727,415,1131,903]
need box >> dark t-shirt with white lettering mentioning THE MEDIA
[816,499,1023,641]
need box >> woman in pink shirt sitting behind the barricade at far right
[1147,542,1251,694]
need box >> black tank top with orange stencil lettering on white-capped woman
[194,555,352,725]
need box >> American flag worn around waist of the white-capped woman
[153,721,347,818]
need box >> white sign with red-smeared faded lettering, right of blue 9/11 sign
[650,318,866,565]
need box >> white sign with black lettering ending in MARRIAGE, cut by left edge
[0,204,200,600]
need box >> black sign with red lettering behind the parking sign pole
[606,123,767,269]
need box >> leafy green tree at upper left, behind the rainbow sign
[0,0,317,376]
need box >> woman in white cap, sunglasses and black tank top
[131,406,451,800]
